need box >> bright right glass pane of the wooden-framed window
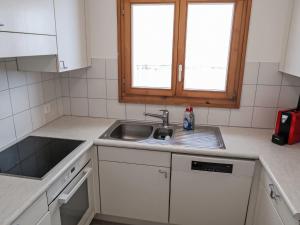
[184,3,234,91]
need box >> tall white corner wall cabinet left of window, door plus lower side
[17,0,88,72]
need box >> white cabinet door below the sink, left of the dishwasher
[99,161,170,223]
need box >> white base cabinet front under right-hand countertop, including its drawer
[254,170,300,225]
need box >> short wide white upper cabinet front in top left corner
[0,0,56,35]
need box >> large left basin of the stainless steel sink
[110,124,153,141]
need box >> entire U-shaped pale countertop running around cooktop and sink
[0,116,300,225]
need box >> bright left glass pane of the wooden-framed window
[131,4,175,89]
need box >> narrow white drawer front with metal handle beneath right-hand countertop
[260,170,299,225]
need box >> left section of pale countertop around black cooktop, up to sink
[0,117,114,225]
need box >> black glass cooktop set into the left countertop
[0,136,83,179]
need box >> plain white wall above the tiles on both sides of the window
[87,0,291,62]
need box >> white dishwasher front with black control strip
[170,154,255,225]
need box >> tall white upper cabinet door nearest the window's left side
[54,0,87,72]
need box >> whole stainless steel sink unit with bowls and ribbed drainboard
[100,120,225,149]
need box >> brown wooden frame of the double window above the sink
[117,0,252,108]
